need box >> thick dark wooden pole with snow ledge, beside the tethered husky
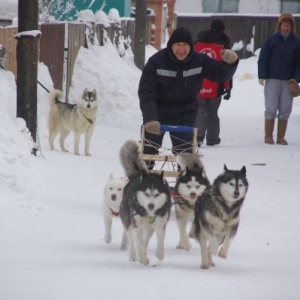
[16,0,40,154]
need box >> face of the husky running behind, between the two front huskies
[175,169,209,201]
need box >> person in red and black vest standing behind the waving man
[194,19,232,147]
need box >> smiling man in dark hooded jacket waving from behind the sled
[138,27,238,168]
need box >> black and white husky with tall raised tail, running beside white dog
[120,140,171,265]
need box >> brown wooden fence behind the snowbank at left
[0,19,135,99]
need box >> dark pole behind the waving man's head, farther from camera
[133,0,147,70]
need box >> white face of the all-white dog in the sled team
[104,174,127,212]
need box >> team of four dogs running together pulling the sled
[103,140,248,269]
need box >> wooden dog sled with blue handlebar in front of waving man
[141,125,198,178]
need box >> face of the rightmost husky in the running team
[219,165,248,204]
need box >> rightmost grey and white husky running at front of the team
[194,165,249,269]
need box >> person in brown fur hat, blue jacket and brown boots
[258,13,300,145]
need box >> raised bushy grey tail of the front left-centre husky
[120,140,148,179]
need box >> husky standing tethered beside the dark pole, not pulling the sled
[48,89,98,156]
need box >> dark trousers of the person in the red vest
[195,96,221,142]
